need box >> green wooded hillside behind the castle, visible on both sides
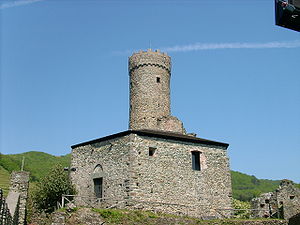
[0,151,300,201]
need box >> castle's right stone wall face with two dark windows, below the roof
[127,135,231,217]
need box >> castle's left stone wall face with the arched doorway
[70,136,131,205]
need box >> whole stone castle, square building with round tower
[70,50,231,218]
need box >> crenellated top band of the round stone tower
[128,49,171,74]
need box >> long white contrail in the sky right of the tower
[161,40,300,52]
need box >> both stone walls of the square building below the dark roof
[71,134,231,217]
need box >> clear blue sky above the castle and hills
[0,0,300,182]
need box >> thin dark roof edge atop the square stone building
[71,130,229,149]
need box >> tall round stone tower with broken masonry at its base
[128,49,185,133]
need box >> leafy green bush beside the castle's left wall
[33,165,75,213]
